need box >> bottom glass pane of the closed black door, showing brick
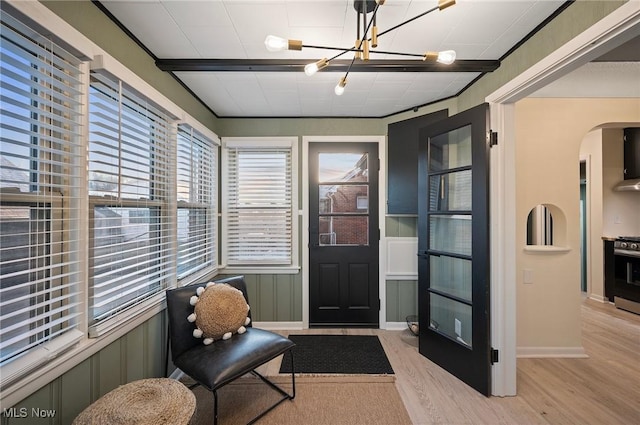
[318,216,369,246]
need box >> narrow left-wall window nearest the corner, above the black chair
[177,124,218,279]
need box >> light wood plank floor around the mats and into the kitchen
[263,300,640,425]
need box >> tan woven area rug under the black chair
[191,375,411,425]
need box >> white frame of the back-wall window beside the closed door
[221,136,300,274]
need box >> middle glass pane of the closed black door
[318,185,369,214]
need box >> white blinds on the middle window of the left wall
[89,72,175,325]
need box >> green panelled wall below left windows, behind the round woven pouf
[1,313,167,425]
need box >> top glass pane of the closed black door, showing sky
[318,152,369,183]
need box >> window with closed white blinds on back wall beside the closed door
[223,138,297,267]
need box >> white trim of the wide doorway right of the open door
[486,1,640,396]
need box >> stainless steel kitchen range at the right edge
[613,236,640,314]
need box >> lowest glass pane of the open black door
[429,293,473,348]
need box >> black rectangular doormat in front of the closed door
[280,335,393,374]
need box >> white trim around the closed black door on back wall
[302,135,387,329]
